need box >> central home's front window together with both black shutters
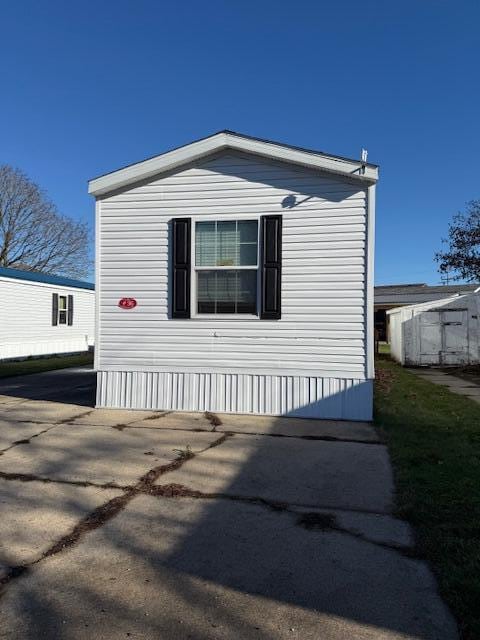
[172,215,282,320]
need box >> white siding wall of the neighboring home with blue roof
[0,277,95,360]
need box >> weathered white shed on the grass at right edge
[387,292,480,366]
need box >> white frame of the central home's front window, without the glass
[190,214,260,321]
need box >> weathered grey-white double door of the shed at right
[419,309,468,365]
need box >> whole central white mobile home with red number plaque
[89,131,378,420]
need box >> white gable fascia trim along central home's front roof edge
[88,133,378,196]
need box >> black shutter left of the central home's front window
[172,218,192,318]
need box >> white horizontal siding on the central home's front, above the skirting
[97,152,371,418]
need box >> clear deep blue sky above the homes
[0,0,480,284]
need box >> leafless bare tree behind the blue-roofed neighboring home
[0,165,90,277]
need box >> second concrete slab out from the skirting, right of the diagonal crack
[158,435,393,513]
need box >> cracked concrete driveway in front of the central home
[0,370,457,640]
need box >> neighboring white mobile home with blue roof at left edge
[0,267,95,360]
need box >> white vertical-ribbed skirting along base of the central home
[97,371,372,420]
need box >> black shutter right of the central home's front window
[260,216,282,320]
